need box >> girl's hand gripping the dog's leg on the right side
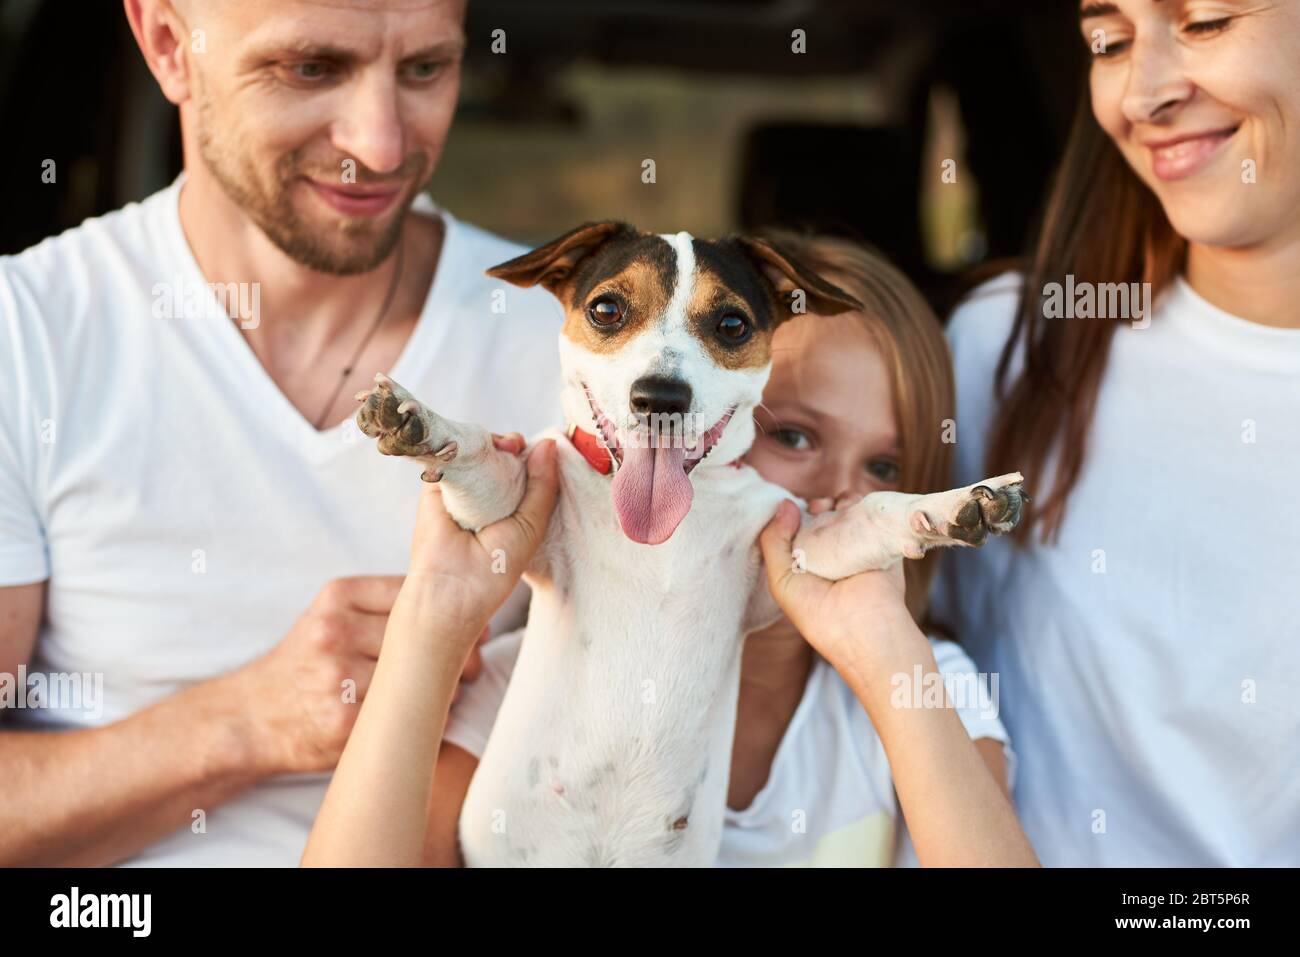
[758,499,928,685]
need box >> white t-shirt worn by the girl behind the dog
[443,629,1015,867]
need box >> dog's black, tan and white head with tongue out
[488,222,861,545]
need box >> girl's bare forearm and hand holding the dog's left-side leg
[303,436,559,866]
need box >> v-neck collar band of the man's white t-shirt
[168,172,463,465]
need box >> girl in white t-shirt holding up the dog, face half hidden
[304,235,1035,865]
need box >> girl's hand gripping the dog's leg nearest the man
[403,434,559,651]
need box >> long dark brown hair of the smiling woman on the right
[984,92,1186,542]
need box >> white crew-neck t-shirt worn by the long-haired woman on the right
[932,276,1300,866]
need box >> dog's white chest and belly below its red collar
[460,459,771,866]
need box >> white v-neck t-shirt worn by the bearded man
[0,179,563,865]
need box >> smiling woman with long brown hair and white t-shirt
[936,0,1300,866]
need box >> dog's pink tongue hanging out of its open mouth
[612,442,696,545]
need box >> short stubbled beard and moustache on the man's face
[198,92,433,276]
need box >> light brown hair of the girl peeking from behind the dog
[763,229,957,627]
